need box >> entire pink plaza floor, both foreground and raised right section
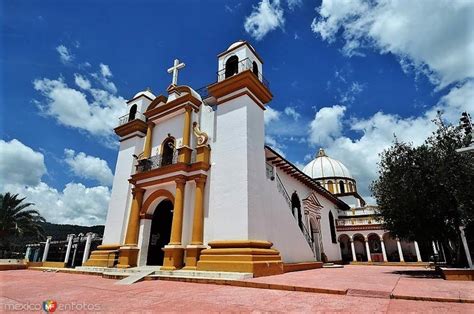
[0,266,474,313]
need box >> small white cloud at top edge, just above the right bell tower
[244,0,285,40]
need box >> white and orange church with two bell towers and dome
[85,41,430,276]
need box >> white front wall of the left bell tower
[102,137,144,244]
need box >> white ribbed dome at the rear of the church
[303,148,354,180]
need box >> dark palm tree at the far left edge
[0,192,46,251]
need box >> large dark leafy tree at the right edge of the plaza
[371,115,474,262]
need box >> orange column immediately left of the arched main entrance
[117,187,145,268]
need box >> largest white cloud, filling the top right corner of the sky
[311,0,474,88]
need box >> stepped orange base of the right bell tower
[197,240,284,277]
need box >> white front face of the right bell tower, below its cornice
[204,96,254,242]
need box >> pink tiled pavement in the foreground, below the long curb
[0,270,474,313]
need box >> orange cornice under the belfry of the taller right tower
[208,70,273,104]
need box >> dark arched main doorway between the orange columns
[147,199,173,265]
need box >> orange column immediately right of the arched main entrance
[161,178,186,270]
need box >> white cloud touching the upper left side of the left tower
[33,74,126,144]
